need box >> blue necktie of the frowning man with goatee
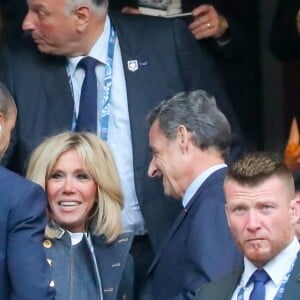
[249,269,270,300]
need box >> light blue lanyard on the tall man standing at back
[67,25,117,141]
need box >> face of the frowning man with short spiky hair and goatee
[224,176,297,267]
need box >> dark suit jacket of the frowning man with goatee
[193,255,300,300]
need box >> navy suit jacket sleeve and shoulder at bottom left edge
[0,167,54,300]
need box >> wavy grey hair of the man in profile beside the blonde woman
[147,90,231,158]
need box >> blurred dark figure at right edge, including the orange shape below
[269,0,300,213]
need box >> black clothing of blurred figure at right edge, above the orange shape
[269,0,300,149]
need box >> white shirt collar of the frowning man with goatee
[242,237,300,287]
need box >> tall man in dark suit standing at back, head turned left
[0,0,241,292]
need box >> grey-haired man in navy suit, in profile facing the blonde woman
[141,91,242,300]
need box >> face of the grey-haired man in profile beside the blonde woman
[148,121,184,199]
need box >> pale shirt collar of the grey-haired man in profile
[182,164,227,207]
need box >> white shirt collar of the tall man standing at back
[68,16,111,75]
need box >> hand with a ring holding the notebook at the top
[189,4,228,40]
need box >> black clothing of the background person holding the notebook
[109,0,262,149]
